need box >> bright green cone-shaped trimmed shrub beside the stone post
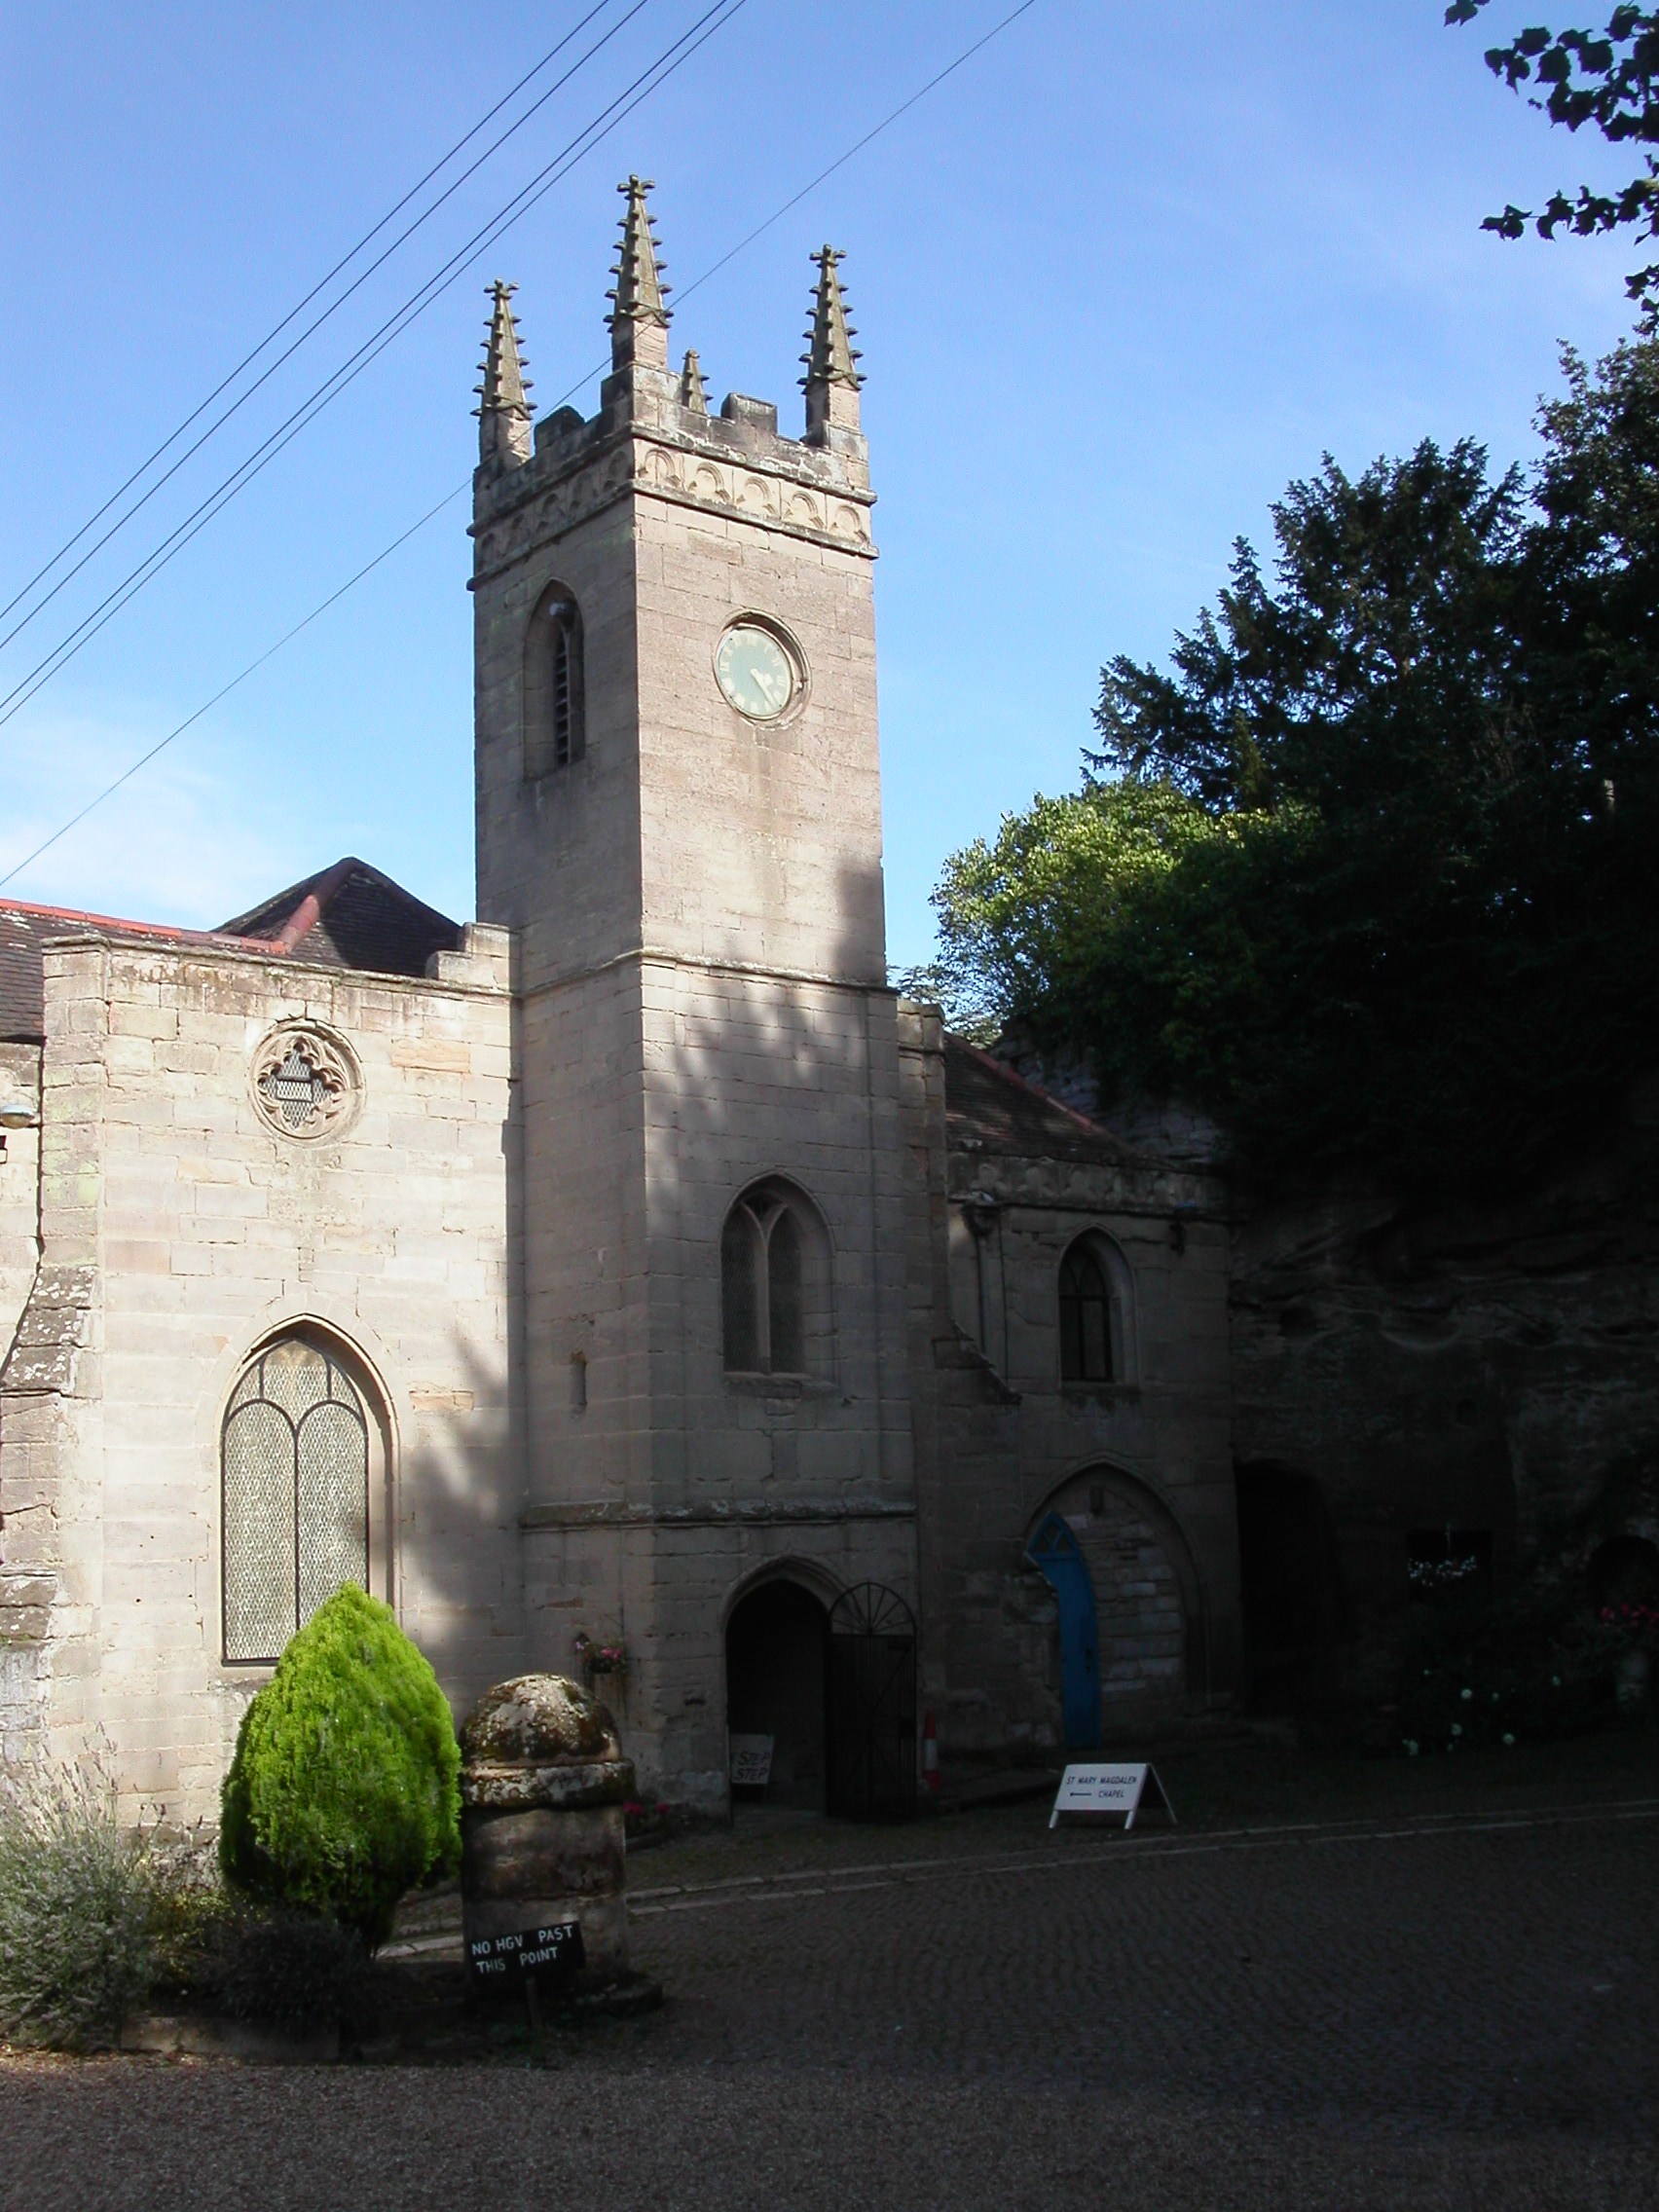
[219,1584,461,1951]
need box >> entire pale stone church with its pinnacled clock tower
[0,179,1238,1821]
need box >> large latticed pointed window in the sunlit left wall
[221,1336,369,1659]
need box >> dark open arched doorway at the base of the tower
[725,1577,830,1812]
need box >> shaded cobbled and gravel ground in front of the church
[0,1794,1659,2212]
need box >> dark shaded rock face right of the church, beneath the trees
[1233,1082,1659,1681]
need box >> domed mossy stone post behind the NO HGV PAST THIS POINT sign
[461,1675,635,1984]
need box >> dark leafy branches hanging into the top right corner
[1447,0,1659,323]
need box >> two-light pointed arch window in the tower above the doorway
[721,1181,830,1376]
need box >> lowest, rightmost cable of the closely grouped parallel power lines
[0,0,748,725]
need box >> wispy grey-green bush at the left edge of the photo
[0,1756,155,2050]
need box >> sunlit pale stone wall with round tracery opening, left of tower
[0,932,522,1821]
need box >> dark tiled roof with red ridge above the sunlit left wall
[0,859,461,1042]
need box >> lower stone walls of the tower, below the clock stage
[527,960,916,1803]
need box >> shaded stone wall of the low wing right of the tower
[904,1009,1241,1754]
